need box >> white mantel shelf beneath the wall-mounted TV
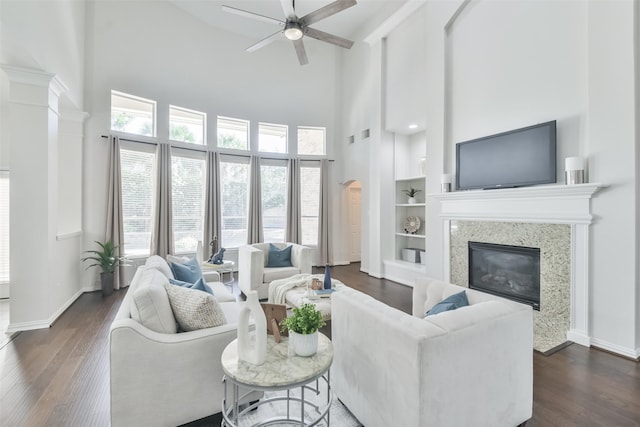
[428,183,605,224]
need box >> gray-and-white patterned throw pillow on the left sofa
[164,283,227,331]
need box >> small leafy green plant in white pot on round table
[280,304,324,356]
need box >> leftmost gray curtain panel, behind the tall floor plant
[105,135,126,289]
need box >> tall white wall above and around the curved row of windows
[83,1,339,283]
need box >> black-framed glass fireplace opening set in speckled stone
[469,242,540,310]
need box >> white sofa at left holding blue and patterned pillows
[109,257,261,427]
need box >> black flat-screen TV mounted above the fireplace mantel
[456,120,556,190]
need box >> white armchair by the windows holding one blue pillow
[238,243,313,299]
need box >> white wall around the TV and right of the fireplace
[418,0,639,356]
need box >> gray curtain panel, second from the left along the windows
[151,144,173,258]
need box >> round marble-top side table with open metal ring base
[221,333,333,427]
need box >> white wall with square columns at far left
[0,1,85,330]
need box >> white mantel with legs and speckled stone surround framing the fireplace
[432,183,603,351]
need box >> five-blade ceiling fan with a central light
[222,0,357,65]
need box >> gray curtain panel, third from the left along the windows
[208,151,222,261]
